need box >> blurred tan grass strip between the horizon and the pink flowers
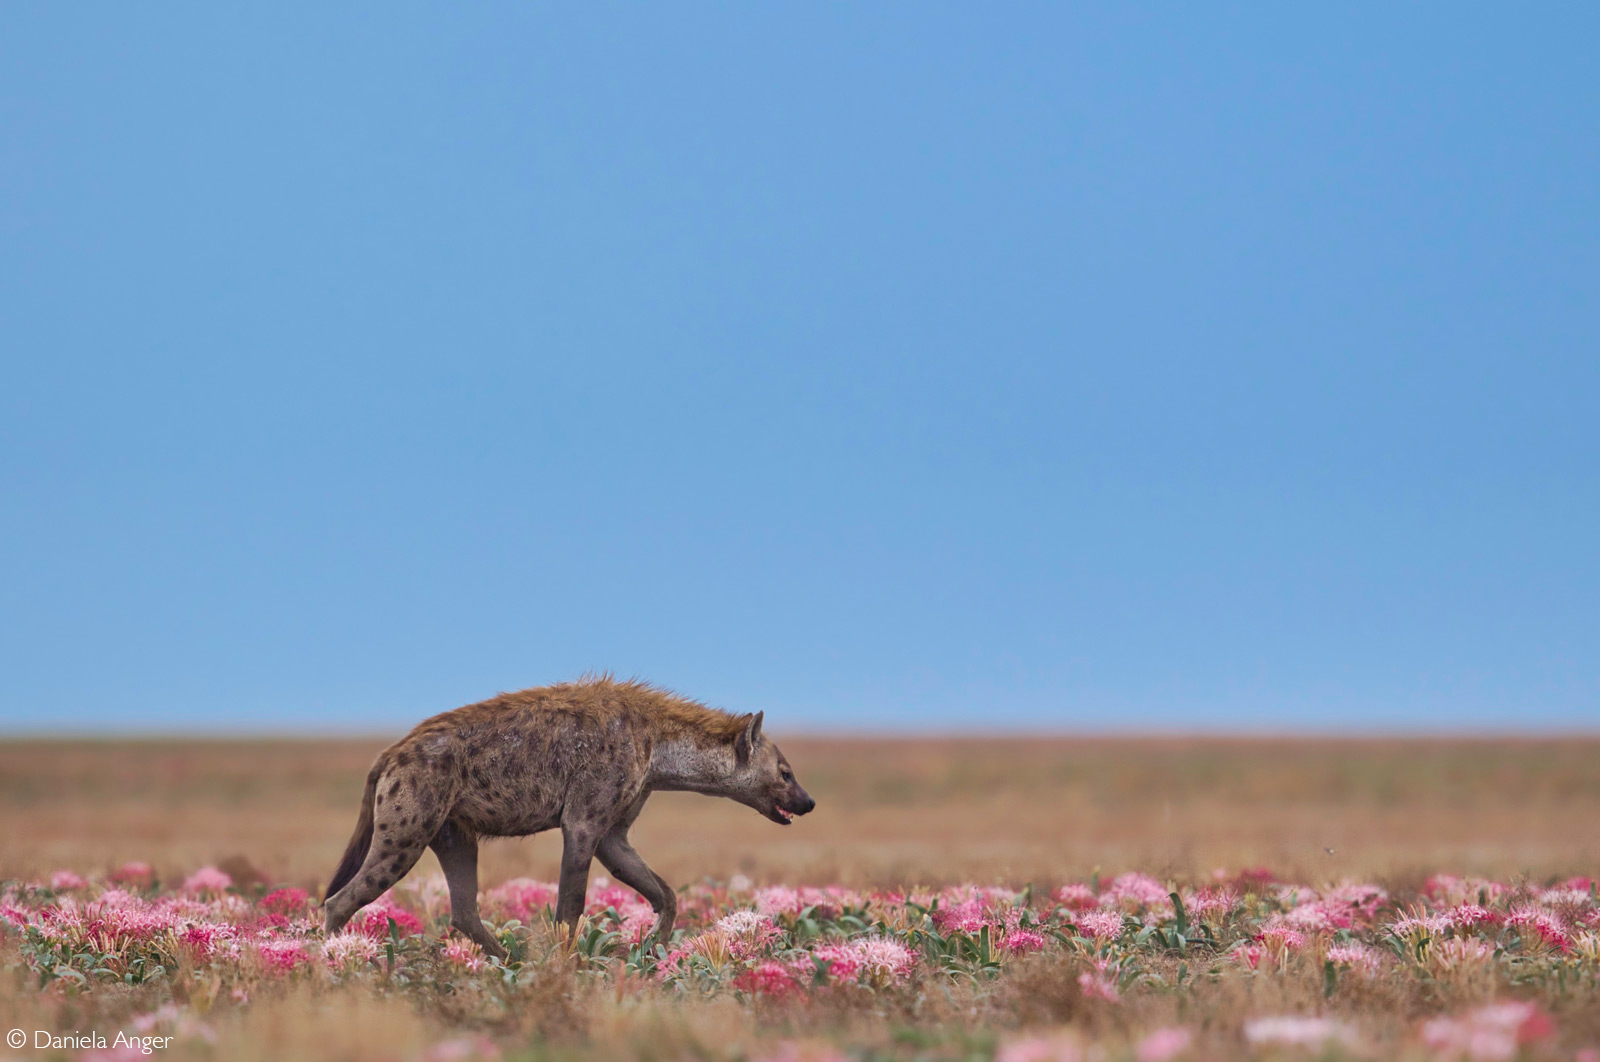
[0,737,1600,892]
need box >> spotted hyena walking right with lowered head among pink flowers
[325,678,816,956]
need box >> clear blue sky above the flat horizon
[0,3,1600,733]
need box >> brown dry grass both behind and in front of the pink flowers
[0,739,1600,1062]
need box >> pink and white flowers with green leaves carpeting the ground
[0,864,1600,1062]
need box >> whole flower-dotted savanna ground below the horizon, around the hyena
[0,734,1600,1059]
